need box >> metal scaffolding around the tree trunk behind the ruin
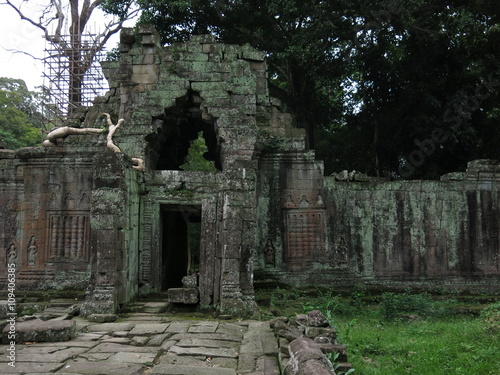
[42,34,108,126]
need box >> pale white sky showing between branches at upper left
[0,5,135,90]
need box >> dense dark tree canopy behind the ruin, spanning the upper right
[103,0,500,178]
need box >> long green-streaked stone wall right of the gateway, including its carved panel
[256,159,500,291]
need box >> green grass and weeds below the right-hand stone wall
[261,289,500,375]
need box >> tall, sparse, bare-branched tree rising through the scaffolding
[3,0,138,112]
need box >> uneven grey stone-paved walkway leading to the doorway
[0,313,280,375]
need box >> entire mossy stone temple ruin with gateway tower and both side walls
[0,27,500,315]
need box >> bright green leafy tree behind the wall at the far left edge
[0,78,41,149]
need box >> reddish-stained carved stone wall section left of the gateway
[0,148,92,289]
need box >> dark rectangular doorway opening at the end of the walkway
[161,205,201,290]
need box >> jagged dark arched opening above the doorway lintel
[146,90,222,171]
